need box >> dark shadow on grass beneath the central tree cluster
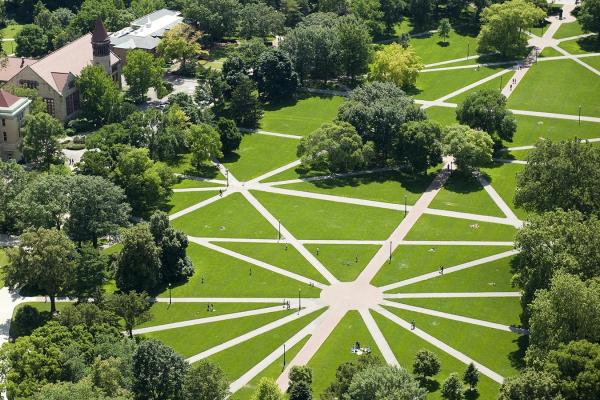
[312,171,434,193]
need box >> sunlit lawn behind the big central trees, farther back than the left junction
[260,96,344,136]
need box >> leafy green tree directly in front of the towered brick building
[75,65,123,126]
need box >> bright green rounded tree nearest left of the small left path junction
[114,149,174,216]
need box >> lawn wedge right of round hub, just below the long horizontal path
[371,245,510,286]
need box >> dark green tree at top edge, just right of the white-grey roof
[183,0,242,41]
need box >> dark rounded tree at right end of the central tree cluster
[394,120,443,173]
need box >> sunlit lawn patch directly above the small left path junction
[222,134,299,181]
